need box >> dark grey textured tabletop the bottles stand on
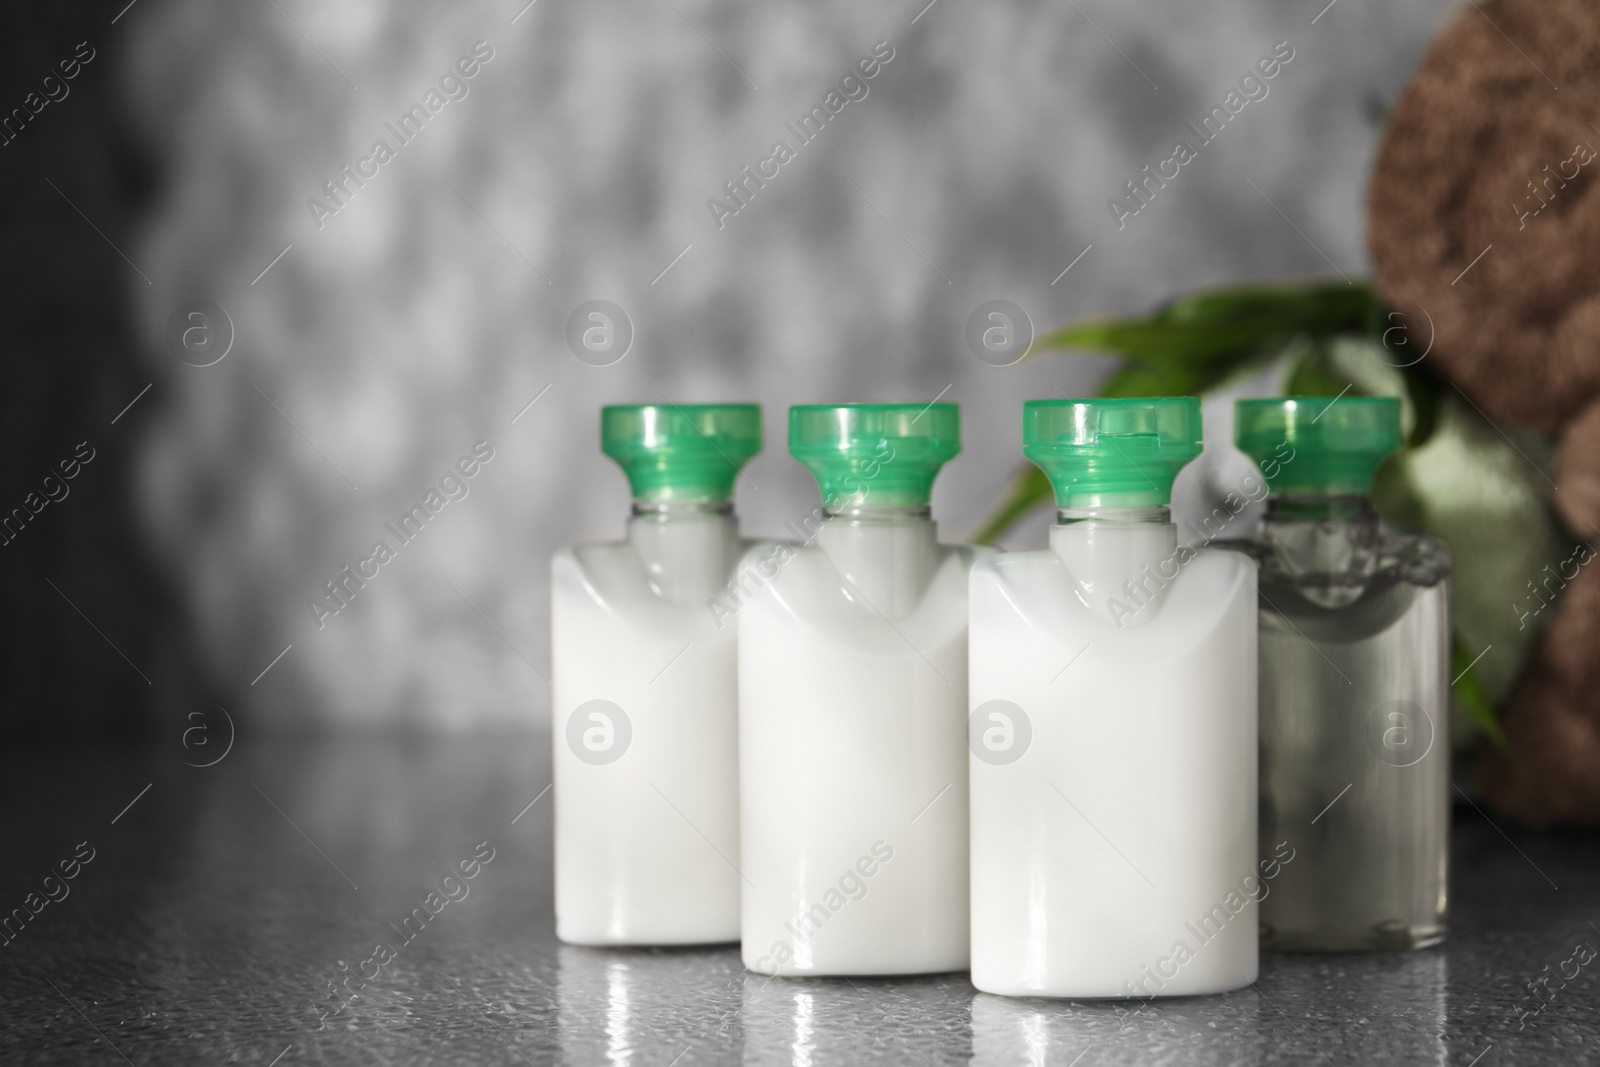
[0,735,1600,1067]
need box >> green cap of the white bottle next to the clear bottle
[1022,397,1200,507]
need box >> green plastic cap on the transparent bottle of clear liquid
[1234,395,1402,496]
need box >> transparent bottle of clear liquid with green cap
[1234,397,1450,952]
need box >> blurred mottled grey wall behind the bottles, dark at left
[0,0,1451,744]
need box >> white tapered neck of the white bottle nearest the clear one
[1050,506,1186,629]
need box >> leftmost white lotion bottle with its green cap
[550,403,762,945]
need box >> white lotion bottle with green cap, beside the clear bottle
[970,397,1264,998]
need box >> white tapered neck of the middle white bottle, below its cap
[816,504,939,619]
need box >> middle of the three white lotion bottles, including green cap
[738,403,976,976]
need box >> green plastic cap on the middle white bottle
[789,403,962,510]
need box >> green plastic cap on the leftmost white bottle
[600,403,762,504]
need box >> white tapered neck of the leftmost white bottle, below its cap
[627,501,739,603]
